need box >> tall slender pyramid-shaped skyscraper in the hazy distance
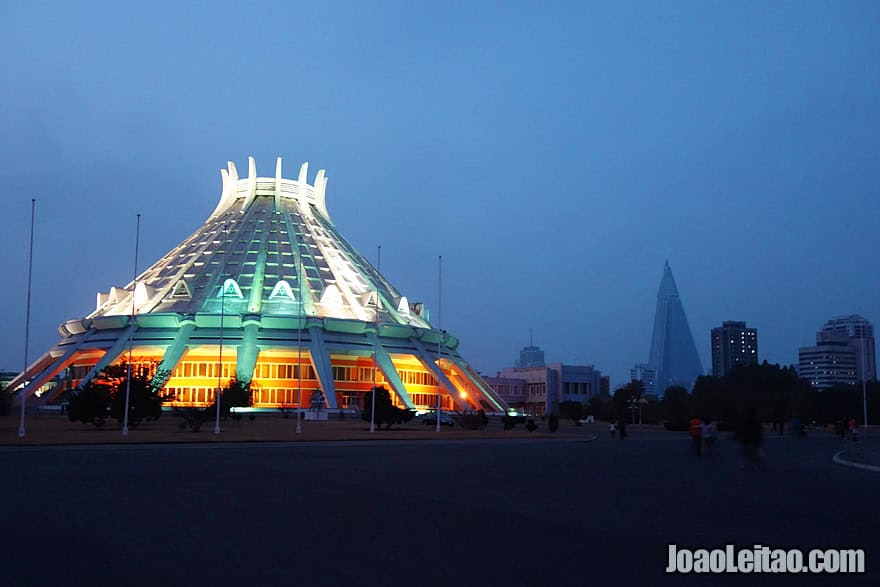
[649,261,703,396]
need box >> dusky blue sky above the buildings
[0,0,880,386]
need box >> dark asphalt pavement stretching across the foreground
[0,430,880,586]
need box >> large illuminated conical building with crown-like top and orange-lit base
[12,158,506,412]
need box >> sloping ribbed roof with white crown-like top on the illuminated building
[86,157,431,328]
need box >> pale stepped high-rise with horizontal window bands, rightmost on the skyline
[798,314,877,389]
